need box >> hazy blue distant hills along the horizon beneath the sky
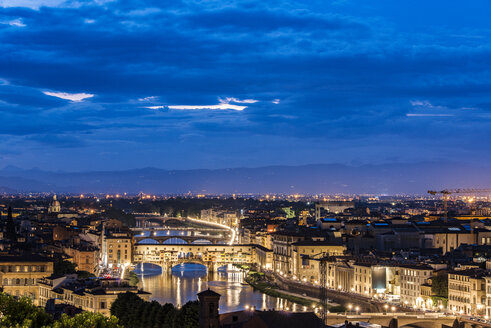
[0,163,491,195]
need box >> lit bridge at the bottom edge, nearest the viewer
[326,312,460,328]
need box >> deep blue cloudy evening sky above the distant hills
[0,0,491,171]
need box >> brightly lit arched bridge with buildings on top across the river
[133,244,256,271]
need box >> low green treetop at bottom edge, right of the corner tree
[51,312,123,328]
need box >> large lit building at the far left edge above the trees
[0,254,53,300]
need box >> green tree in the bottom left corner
[0,293,53,328]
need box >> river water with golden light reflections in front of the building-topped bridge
[135,263,303,313]
